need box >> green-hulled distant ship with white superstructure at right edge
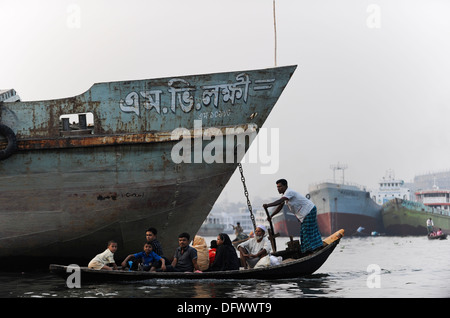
[382,187,450,235]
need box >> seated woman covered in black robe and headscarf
[209,233,240,272]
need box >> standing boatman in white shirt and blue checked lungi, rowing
[263,179,323,253]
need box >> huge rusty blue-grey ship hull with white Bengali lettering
[0,66,295,265]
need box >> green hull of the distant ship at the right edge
[382,199,450,236]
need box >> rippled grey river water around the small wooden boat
[0,236,450,302]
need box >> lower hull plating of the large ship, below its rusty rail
[0,143,236,259]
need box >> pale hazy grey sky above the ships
[0,0,450,202]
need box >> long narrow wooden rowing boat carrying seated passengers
[50,230,344,282]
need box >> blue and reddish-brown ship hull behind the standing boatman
[309,182,383,235]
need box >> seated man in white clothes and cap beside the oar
[237,225,272,268]
